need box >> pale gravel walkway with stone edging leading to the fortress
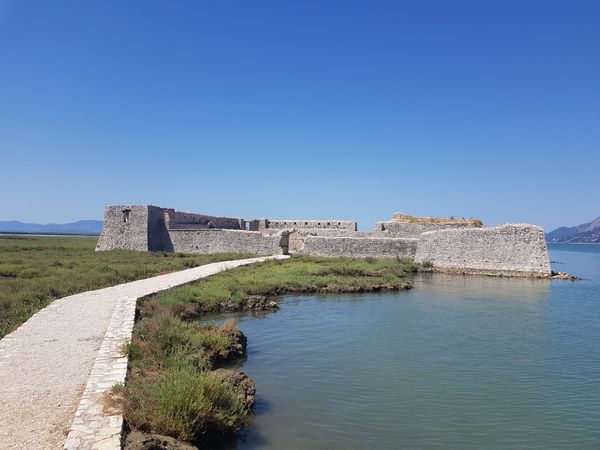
[0,256,285,449]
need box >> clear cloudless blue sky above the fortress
[0,0,600,229]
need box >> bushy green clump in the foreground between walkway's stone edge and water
[123,310,250,442]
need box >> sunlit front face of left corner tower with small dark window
[96,205,155,251]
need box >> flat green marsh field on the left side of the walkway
[0,235,247,338]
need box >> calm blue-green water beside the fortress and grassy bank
[221,245,600,450]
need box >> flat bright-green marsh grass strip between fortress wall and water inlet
[141,256,418,315]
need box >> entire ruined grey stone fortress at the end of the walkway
[96,205,552,278]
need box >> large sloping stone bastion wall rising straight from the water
[415,225,551,277]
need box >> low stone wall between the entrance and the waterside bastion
[299,236,418,258]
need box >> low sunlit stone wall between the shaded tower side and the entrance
[165,229,288,255]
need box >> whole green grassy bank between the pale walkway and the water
[124,257,417,444]
